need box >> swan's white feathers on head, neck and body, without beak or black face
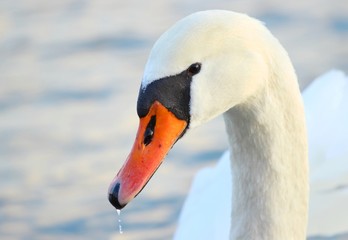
[135,10,348,240]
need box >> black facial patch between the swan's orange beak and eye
[137,63,201,127]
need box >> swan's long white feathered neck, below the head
[224,74,308,239]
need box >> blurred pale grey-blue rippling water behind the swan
[0,0,348,239]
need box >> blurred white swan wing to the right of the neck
[303,70,348,236]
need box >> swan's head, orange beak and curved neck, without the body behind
[108,10,309,240]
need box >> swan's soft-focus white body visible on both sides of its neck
[174,71,348,240]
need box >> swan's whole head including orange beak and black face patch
[109,10,271,209]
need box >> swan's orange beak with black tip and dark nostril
[109,101,187,209]
